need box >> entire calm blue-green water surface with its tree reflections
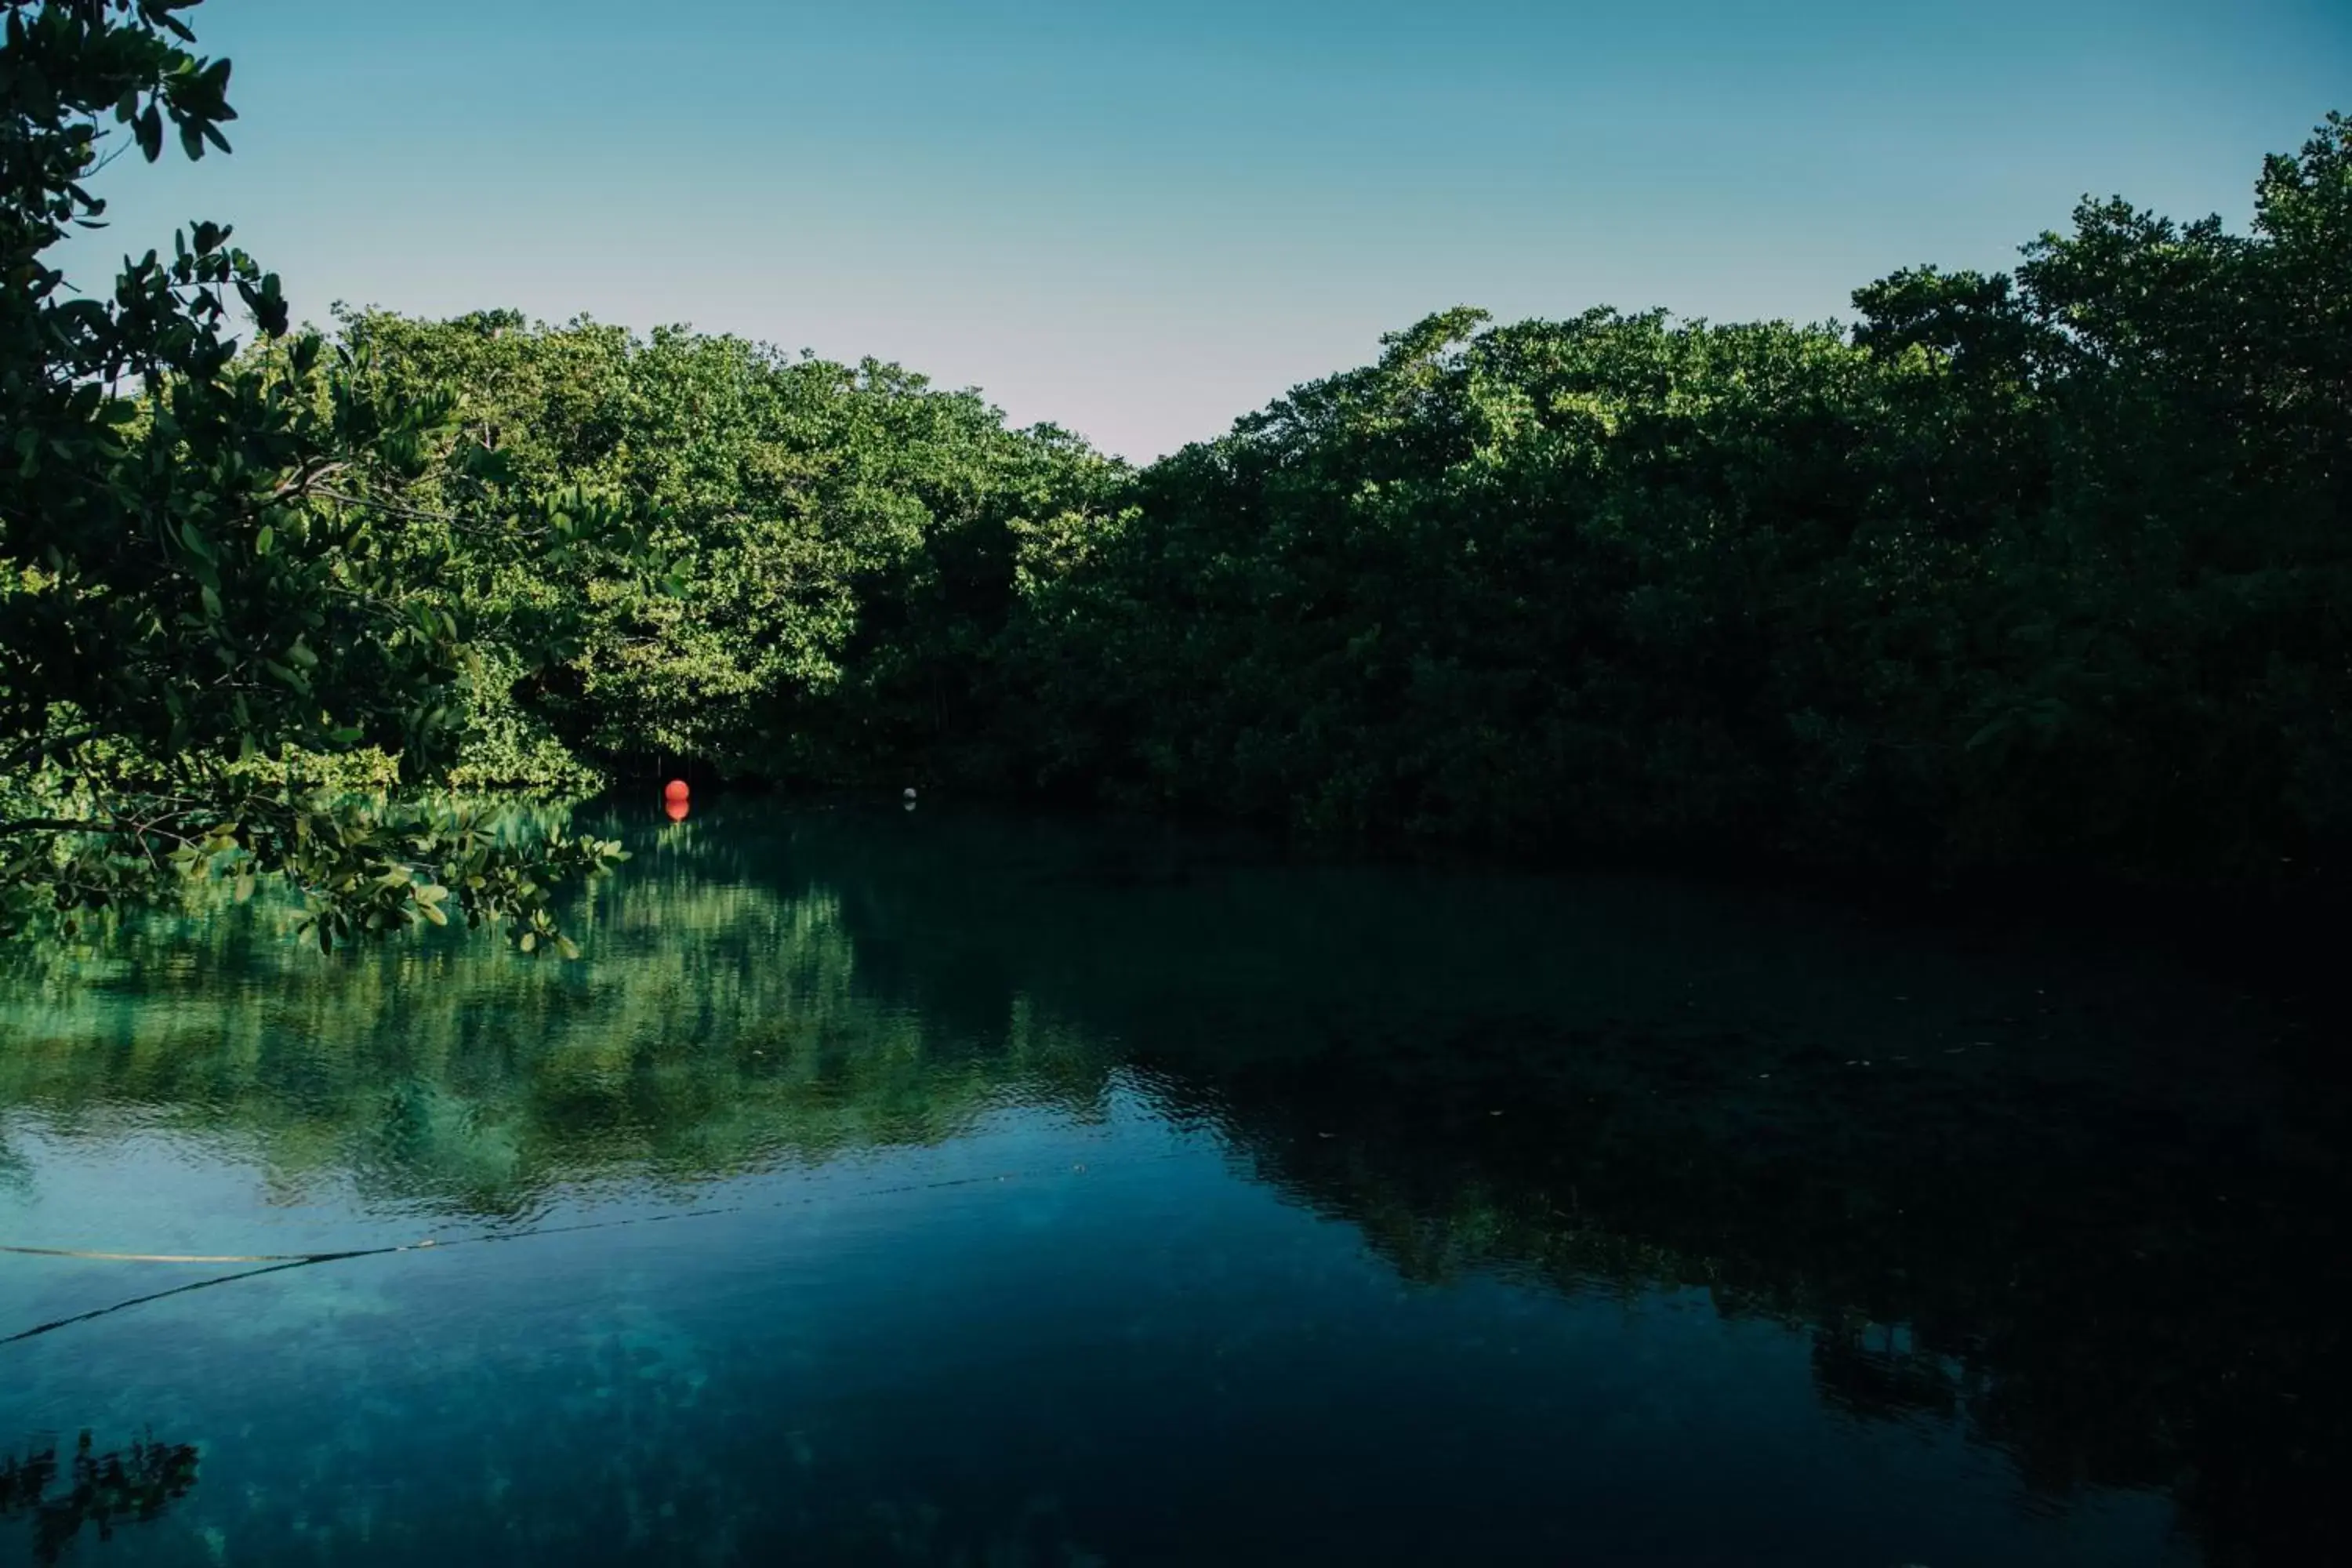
[0,806,2352,1568]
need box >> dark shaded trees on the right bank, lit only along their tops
[1040,118,2352,884]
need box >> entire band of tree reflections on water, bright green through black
[0,804,2352,1563]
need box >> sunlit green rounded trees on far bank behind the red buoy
[343,313,1122,783]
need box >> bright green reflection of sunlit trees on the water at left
[0,825,1103,1218]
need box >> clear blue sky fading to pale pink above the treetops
[55,0,2352,461]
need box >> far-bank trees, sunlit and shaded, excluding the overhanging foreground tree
[346,118,2352,907]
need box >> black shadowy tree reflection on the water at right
[781,804,2352,1563]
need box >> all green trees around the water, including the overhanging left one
[0,0,2352,952]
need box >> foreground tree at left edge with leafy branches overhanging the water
[0,0,621,947]
